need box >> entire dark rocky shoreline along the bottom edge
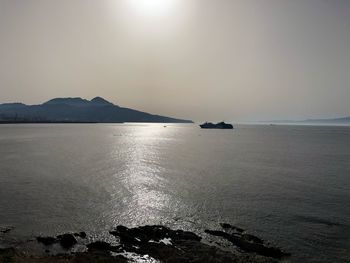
[0,223,290,263]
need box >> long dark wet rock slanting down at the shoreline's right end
[205,230,290,259]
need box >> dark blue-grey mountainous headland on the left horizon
[0,97,193,123]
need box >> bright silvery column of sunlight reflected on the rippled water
[112,125,172,227]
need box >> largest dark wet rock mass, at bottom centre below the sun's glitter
[110,226,276,263]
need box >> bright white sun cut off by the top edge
[126,0,177,16]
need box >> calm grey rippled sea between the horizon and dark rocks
[0,124,350,262]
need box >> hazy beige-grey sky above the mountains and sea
[0,0,350,121]
